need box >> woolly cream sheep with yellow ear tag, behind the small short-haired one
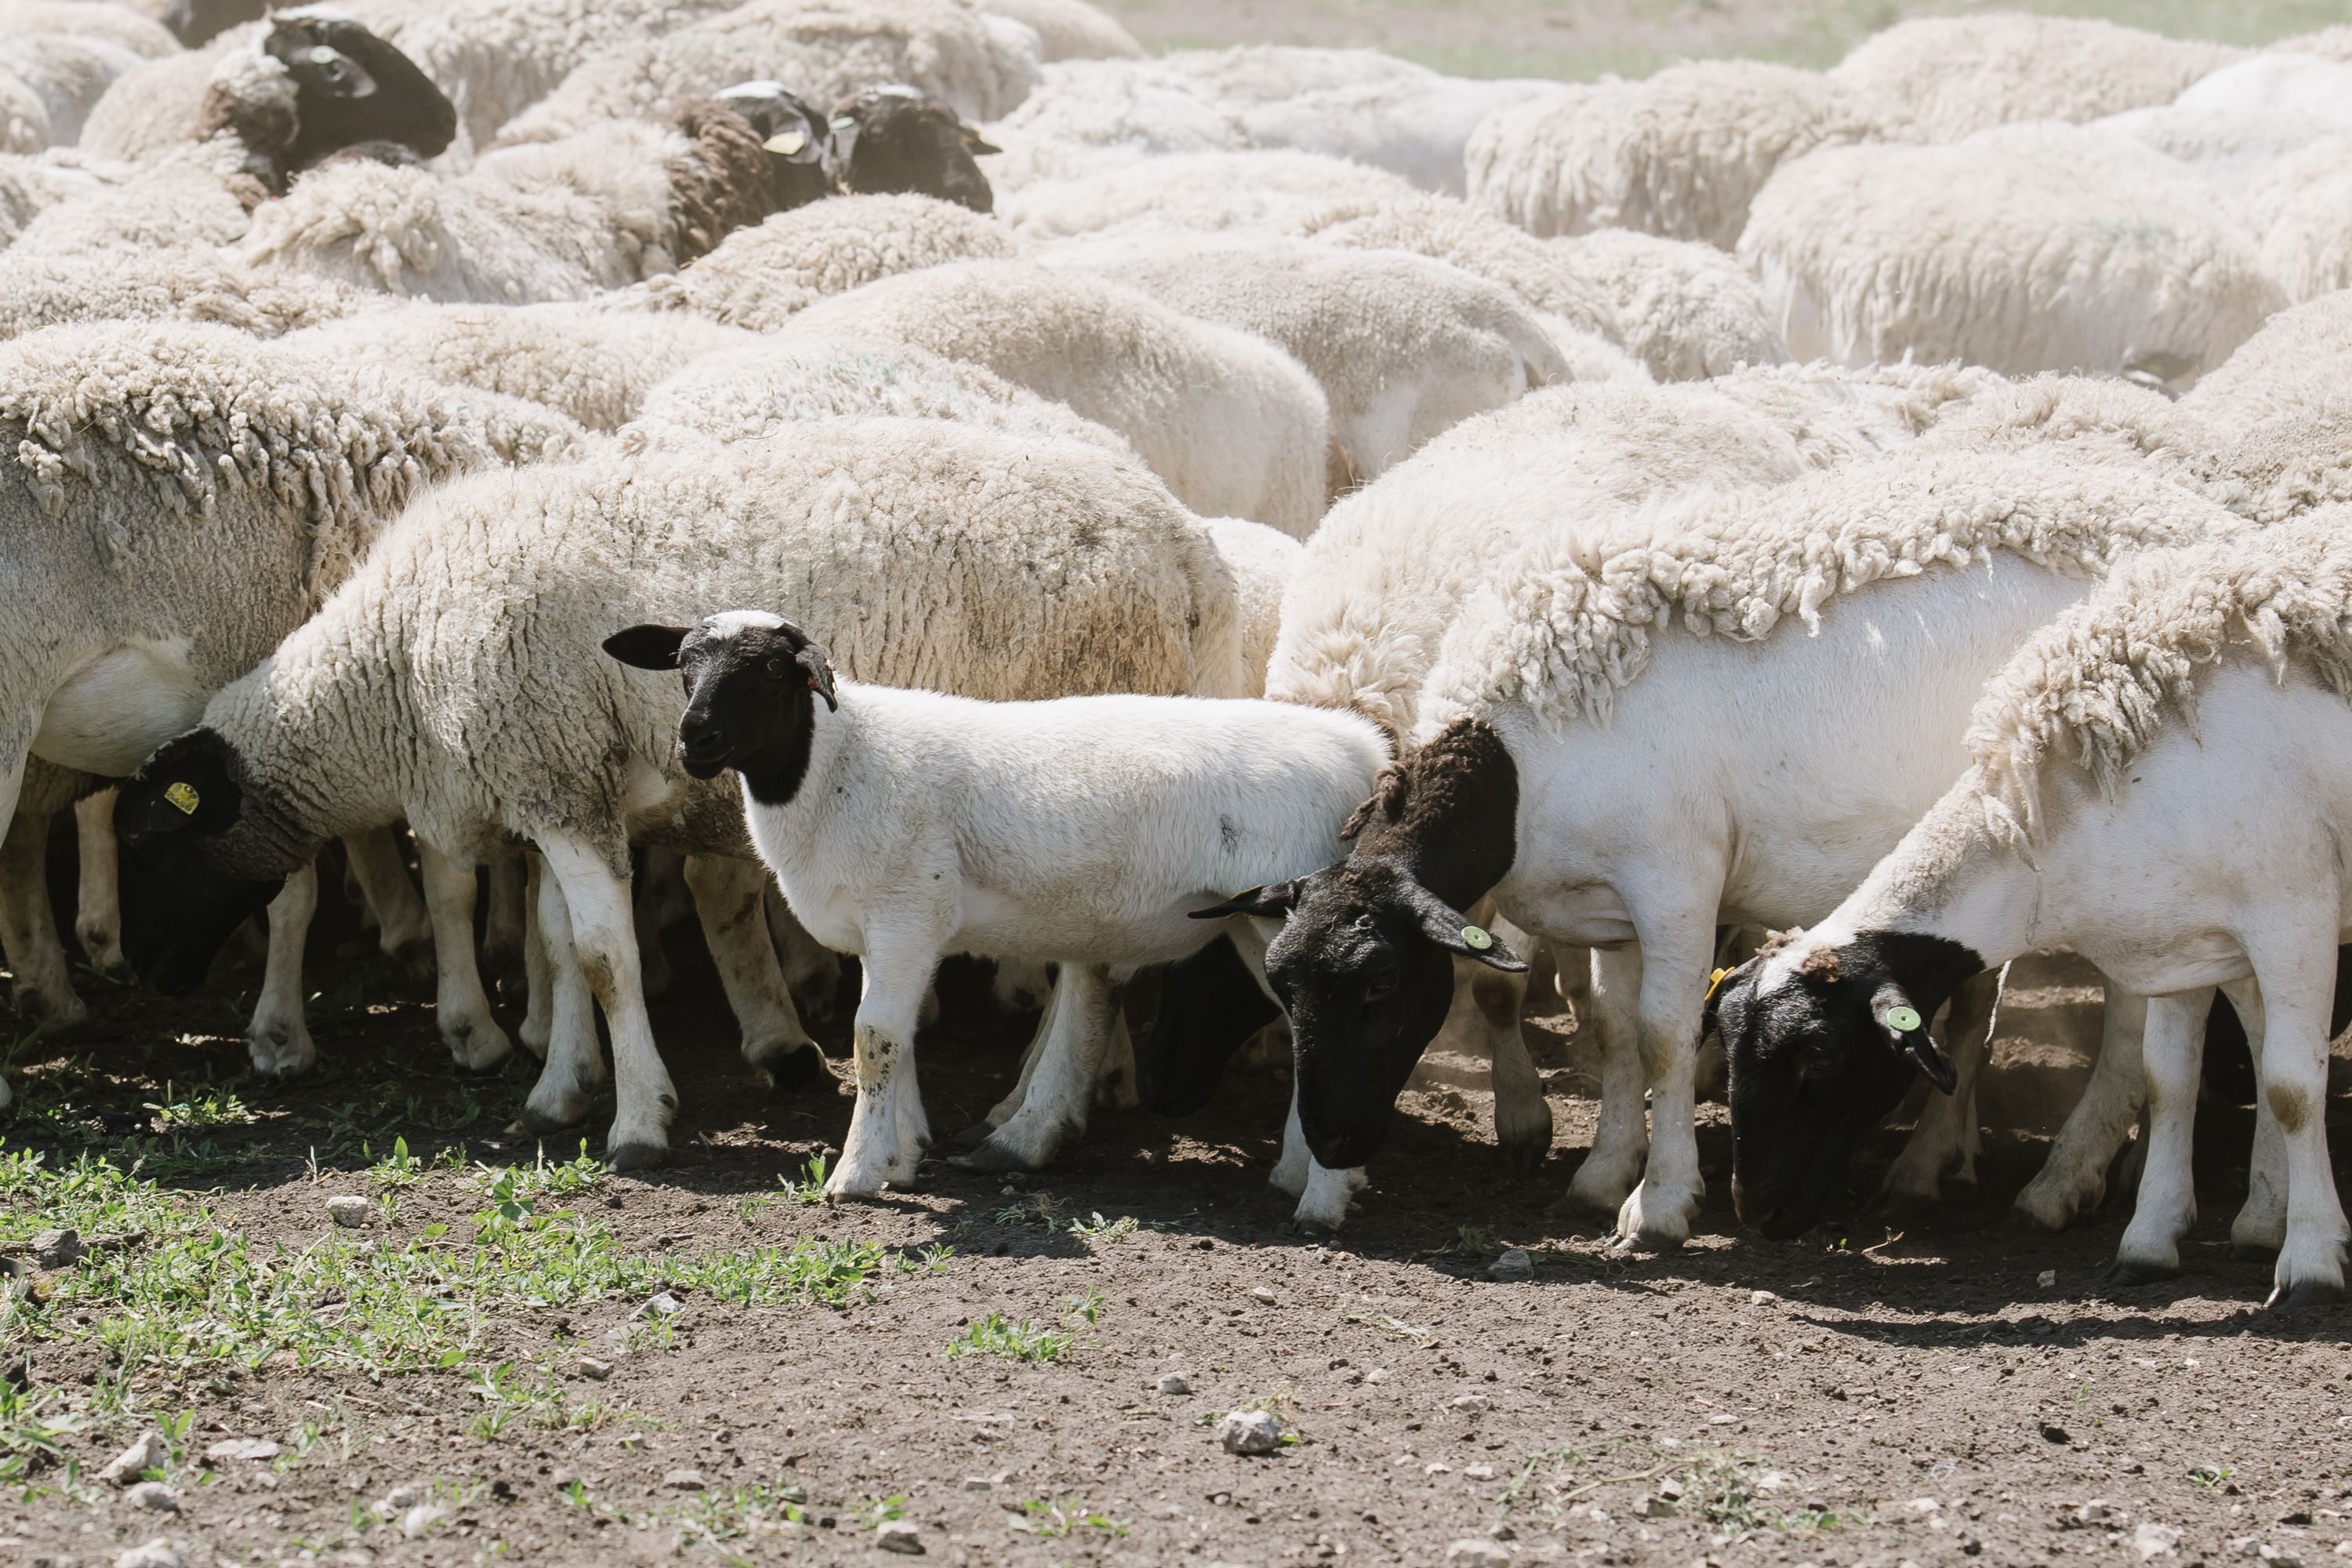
[115,419,1244,1168]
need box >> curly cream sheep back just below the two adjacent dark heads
[633,195,1021,332]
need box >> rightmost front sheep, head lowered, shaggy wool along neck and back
[1717,515,2352,1309]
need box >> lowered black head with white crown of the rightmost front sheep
[1708,931,1985,1239]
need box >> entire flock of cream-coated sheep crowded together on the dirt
[0,0,2352,1305]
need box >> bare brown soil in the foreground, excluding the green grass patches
[0,846,2352,1568]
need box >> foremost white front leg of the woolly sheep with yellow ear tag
[539,832,677,1171]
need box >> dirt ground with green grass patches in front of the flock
[0,832,2352,1568]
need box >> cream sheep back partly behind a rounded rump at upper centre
[1049,235,1569,480]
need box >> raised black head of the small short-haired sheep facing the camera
[604,609,837,806]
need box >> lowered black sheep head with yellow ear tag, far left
[115,729,320,996]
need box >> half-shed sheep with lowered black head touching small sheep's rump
[1218,446,2239,1246]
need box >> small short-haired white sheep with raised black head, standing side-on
[604,612,1388,1196]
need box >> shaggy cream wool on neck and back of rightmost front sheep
[1969,510,2352,827]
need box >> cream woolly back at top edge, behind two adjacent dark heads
[499,0,1040,146]
